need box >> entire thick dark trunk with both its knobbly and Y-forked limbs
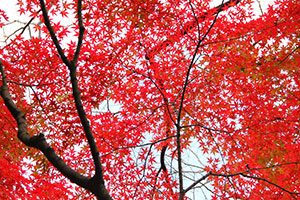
[0,0,112,200]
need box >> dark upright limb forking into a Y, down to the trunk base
[40,0,111,200]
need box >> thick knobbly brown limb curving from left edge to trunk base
[0,60,112,200]
